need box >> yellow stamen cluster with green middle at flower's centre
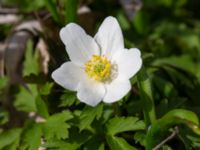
[85,55,111,81]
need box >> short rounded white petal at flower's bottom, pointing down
[77,79,105,106]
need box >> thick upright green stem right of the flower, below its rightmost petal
[137,67,156,127]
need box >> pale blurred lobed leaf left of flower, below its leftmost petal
[14,84,38,112]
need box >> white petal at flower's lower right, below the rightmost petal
[103,78,131,103]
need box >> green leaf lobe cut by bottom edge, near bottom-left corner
[20,122,42,150]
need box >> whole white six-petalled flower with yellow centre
[52,16,142,106]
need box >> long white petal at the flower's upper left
[60,23,100,65]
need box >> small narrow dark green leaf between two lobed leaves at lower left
[36,96,49,118]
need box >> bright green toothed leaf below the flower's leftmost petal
[43,111,73,140]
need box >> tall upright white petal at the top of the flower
[95,16,124,59]
